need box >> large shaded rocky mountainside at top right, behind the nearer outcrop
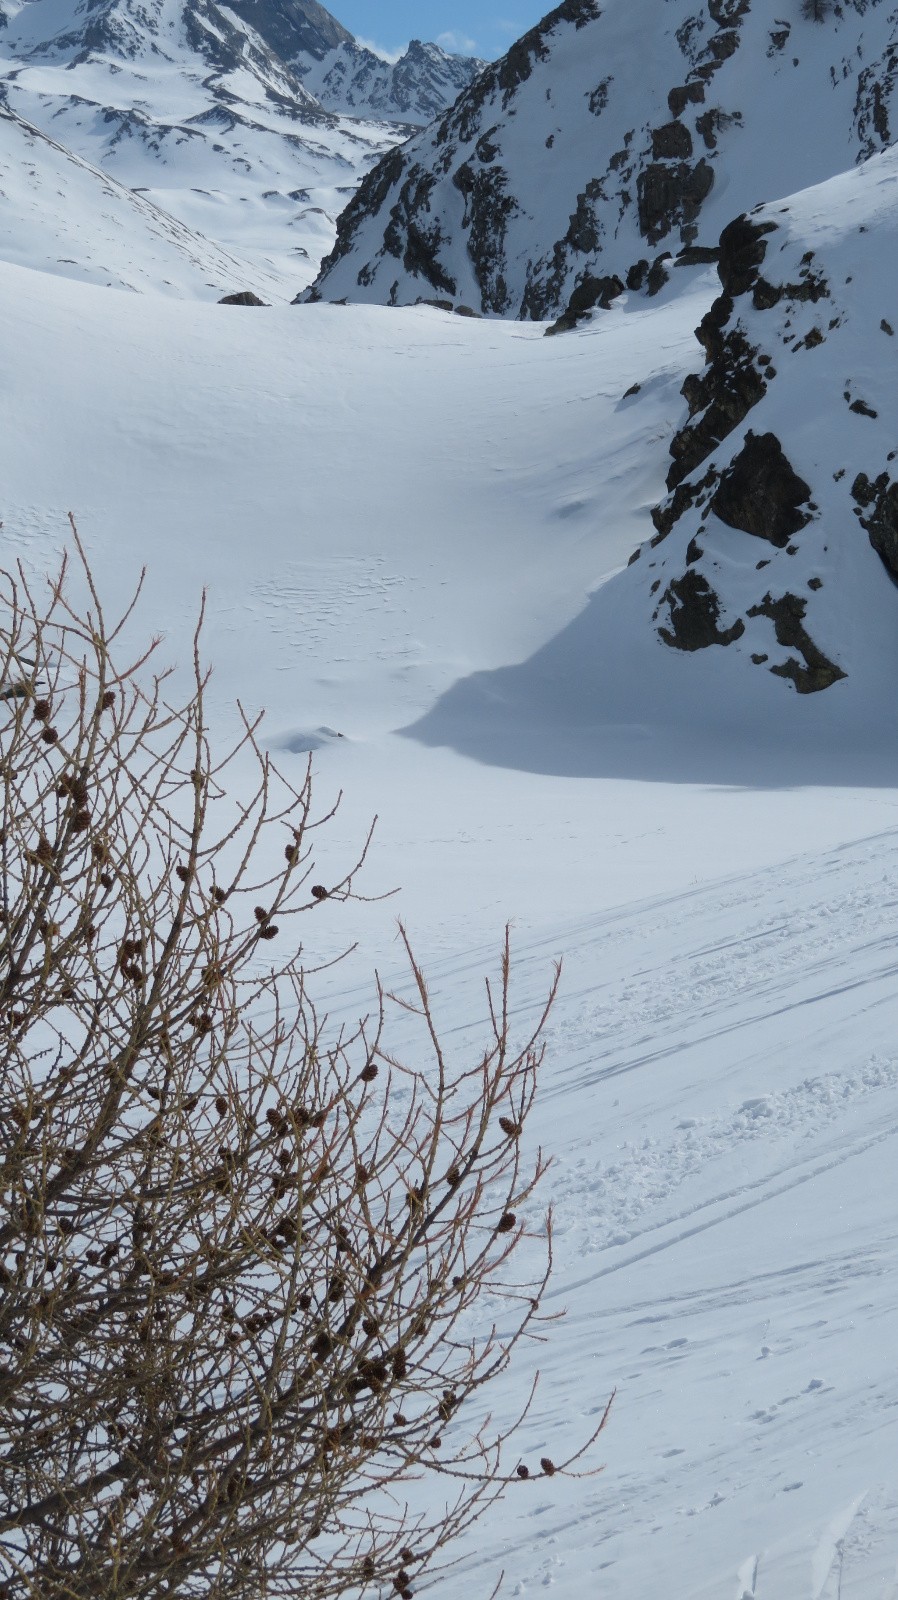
[304,0,898,320]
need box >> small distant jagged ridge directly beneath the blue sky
[290,38,487,123]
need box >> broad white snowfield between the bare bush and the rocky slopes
[0,236,898,1600]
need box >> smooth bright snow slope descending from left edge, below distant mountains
[0,104,279,299]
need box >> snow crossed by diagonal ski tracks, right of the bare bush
[385,830,898,1600]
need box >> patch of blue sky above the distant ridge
[332,0,554,59]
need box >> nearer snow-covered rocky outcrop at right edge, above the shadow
[632,150,898,694]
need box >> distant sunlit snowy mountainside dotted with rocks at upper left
[0,0,407,298]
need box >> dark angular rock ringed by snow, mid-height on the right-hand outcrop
[711,429,812,550]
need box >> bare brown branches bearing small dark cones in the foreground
[0,530,608,1600]
